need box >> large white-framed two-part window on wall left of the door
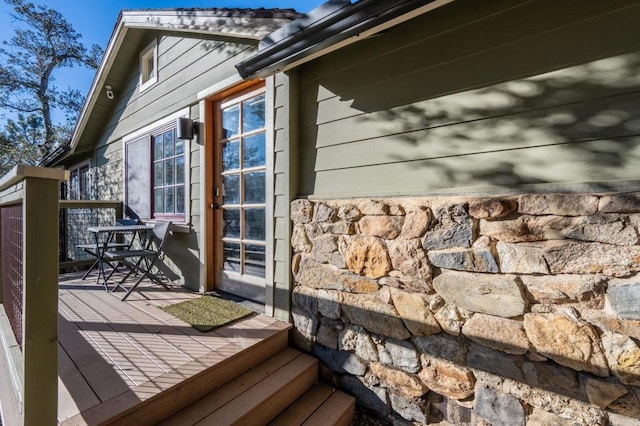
[124,119,188,222]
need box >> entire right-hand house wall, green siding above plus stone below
[283,1,640,425]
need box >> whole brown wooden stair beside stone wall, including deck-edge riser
[92,329,355,426]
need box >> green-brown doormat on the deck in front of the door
[160,296,253,331]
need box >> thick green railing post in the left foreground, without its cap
[22,178,58,425]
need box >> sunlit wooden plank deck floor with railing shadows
[58,275,290,425]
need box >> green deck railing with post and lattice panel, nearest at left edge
[0,165,67,424]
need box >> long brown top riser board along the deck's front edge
[100,324,289,426]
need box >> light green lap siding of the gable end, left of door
[94,37,252,206]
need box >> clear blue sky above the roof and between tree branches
[0,0,326,127]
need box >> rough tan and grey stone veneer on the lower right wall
[291,193,640,426]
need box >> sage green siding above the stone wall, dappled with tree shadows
[298,0,640,197]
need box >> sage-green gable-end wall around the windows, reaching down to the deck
[87,32,254,290]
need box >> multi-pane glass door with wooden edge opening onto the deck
[214,89,267,302]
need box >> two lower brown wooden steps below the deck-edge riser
[160,348,355,426]
